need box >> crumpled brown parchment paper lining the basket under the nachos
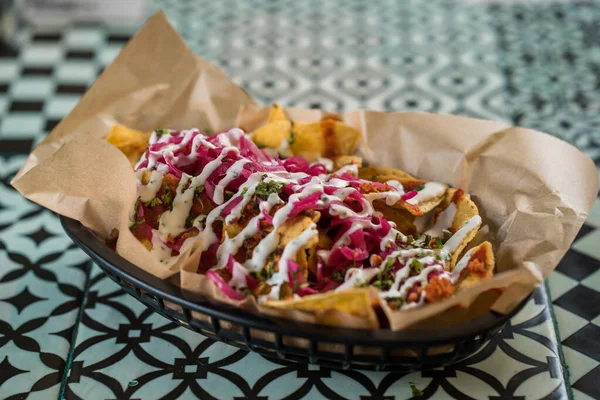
[11,13,598,329]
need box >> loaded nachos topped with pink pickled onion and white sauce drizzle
[107,106,494,322]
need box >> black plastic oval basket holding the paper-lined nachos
[61,217,528,372]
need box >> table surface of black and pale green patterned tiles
[0,0,600,399]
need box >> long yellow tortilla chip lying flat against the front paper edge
[264,288,378,326]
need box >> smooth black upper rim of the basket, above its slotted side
[60,215,531,347]
